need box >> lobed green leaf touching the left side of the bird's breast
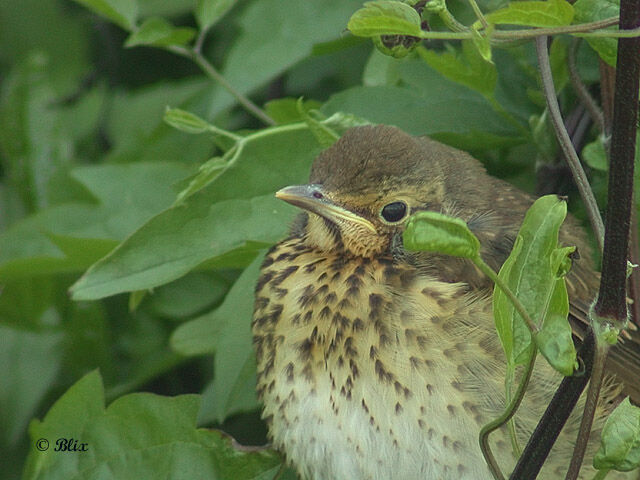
[171,254,264,422]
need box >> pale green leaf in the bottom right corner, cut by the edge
[593,397,640,472]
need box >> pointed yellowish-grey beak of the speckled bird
[276,184,377,233]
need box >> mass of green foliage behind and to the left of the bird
[0,0,636,479]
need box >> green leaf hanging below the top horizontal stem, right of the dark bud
[417,40,498,98]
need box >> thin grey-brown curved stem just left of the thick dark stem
[536,37,604,251]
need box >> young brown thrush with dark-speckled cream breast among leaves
[252,125,640,480]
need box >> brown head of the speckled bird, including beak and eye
[276,125,486,257]
